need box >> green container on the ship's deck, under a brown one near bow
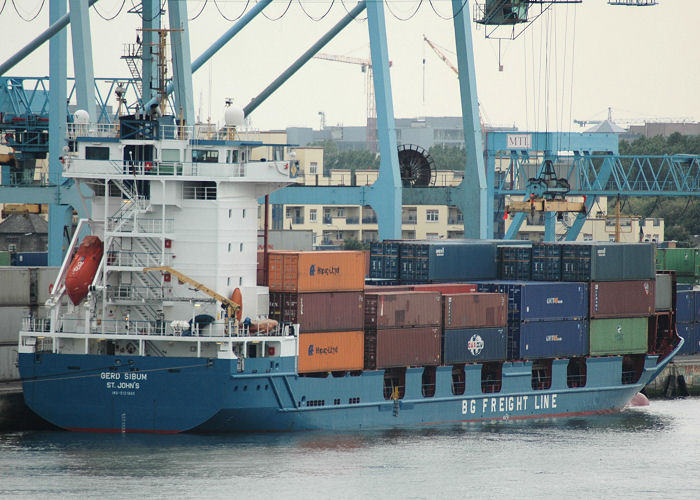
[590,316,648,356]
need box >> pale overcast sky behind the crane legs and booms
[0,0,700,131]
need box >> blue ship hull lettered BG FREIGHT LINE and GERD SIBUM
[19,344,682,433]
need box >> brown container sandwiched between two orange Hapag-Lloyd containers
[270,292,364,332]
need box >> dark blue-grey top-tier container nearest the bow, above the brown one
[561,242,656,281]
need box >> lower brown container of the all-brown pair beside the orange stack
[364,326,442,370]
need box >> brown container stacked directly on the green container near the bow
[590,280,656,318]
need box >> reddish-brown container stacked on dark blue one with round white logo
[442,293,508,364]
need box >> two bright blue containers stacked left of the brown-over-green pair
[479,281,589,359]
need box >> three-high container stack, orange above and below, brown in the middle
[269,251,365,373]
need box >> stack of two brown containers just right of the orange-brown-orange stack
[364,291,441,370]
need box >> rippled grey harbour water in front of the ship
[0,398,700,499]
